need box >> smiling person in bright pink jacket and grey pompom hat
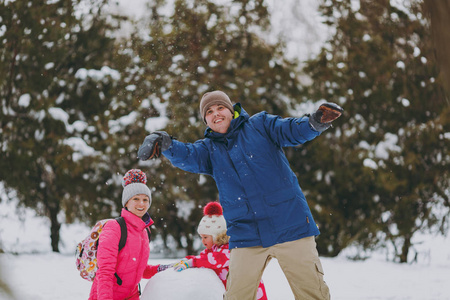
[89,169,162,300]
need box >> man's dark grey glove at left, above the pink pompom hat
[138,131,172,160]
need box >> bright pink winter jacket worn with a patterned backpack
[89,209,158,300]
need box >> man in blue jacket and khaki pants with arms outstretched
[138,91,343,300]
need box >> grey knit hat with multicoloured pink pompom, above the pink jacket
[122,169,152,207]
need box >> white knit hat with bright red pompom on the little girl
[197,202,227,242]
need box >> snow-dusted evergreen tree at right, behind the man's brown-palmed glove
[298,0,450,262]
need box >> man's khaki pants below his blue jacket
[224,236,330,300]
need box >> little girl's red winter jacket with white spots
[186,244,267,300]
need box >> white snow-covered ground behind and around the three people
[0,197,450,300]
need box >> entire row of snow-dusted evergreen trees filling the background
[0,0,450,262]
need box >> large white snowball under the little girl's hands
[141,268,225,300]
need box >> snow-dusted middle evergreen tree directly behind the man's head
[121,0,299,253]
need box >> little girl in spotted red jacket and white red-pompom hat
[174,202,267,300]
